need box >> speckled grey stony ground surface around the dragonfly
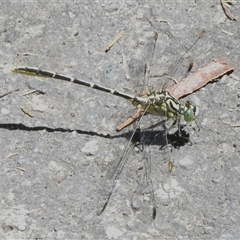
[0,0,240,239]
